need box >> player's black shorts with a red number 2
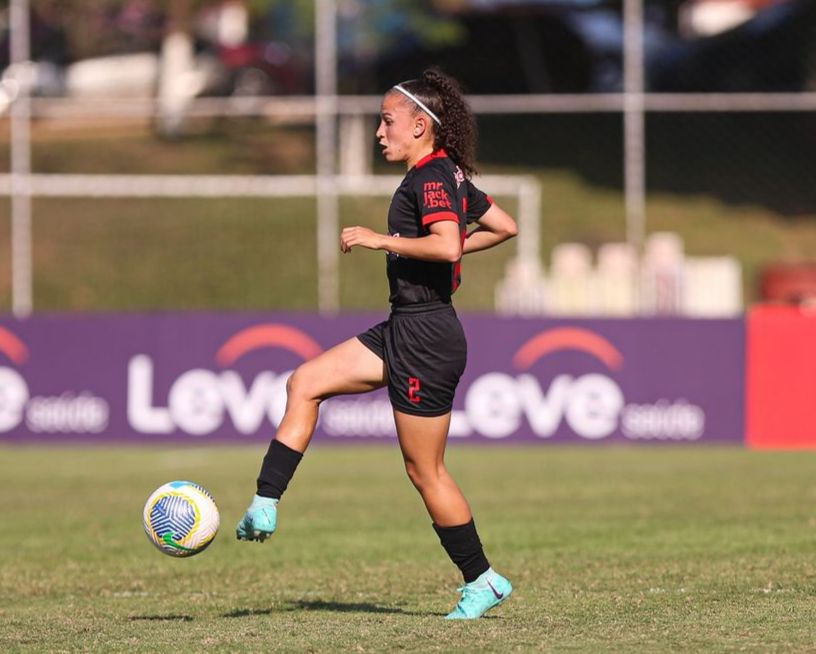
[357,303,467,416]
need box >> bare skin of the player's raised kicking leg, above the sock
[275,338,386,452]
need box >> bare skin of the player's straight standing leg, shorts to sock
[394,411,472,527]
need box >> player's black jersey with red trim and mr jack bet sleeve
[386,150,493,306]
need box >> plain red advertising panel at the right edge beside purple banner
[746,306,816,449]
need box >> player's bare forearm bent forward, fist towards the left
[340,220,462,263]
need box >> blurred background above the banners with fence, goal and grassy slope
[0,0,816,317]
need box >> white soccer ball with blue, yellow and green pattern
[142,481,221,557]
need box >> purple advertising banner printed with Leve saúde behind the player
[0,313,745,443]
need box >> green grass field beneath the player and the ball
[0,446,816,653]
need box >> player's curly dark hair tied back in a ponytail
[390,67,478,179]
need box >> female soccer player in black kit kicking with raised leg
[237,69,516,619]
